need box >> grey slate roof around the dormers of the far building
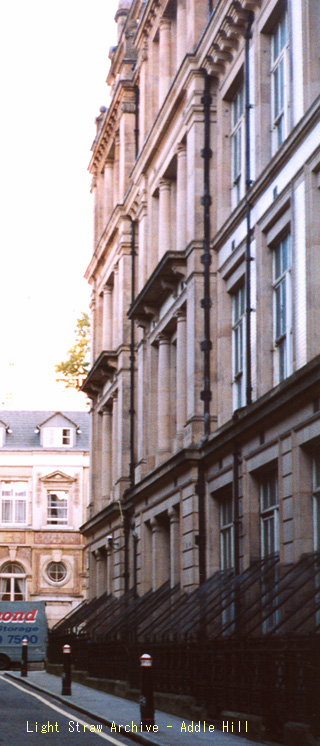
[0,409,90,452]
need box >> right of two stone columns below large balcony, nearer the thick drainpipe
[176,310,187,446]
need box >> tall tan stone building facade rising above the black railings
[82,0,320,597]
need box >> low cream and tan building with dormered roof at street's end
[0,410,89,626]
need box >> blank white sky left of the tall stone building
[0,0,118,409]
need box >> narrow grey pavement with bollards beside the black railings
[5,671,264,746]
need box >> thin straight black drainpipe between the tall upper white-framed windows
[245,11,254,404]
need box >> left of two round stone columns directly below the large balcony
[158,334,170,459]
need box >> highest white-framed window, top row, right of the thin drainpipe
[271,10,289,152]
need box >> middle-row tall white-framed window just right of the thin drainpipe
[273,235,292,383]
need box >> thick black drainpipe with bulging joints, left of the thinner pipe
[200,70,212,440]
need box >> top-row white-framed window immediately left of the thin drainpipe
[231,85,245,205]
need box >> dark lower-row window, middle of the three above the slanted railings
[260,471,279,558]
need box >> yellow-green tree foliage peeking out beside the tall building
[55,313,90,391]
